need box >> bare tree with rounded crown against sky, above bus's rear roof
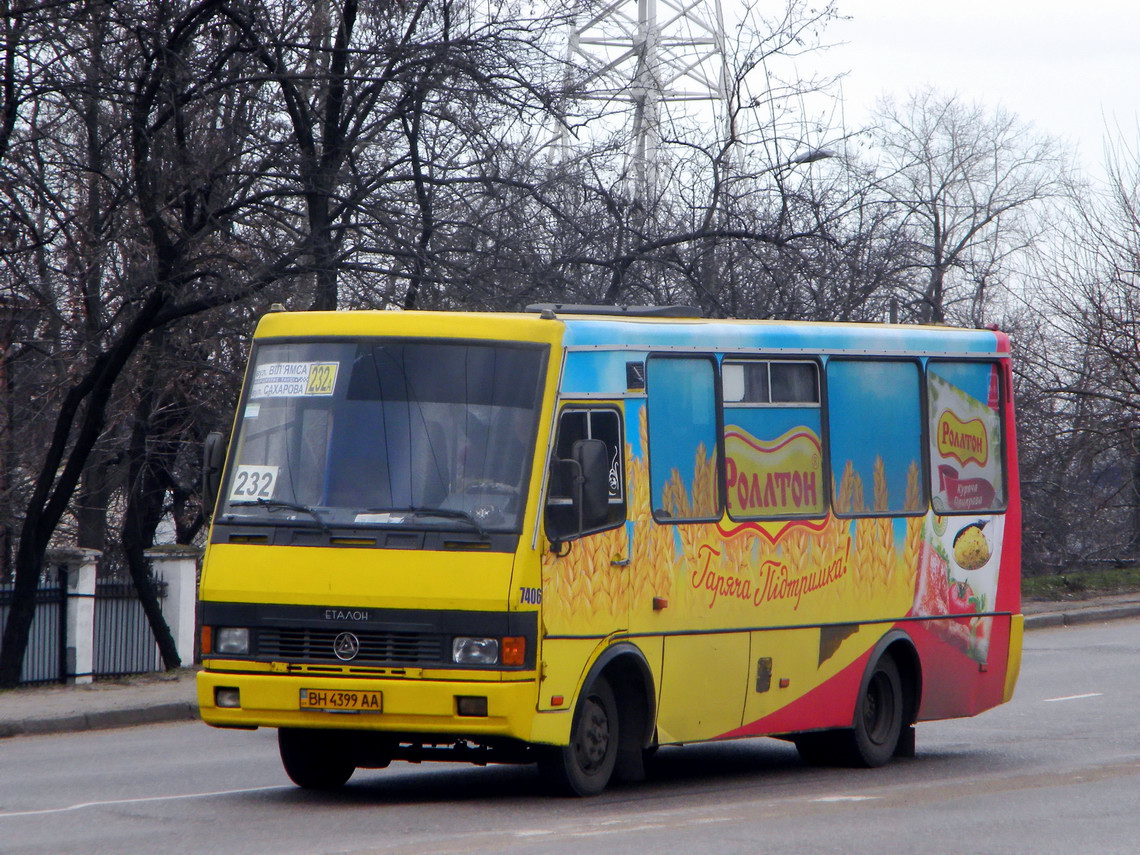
[873,89,1064,325]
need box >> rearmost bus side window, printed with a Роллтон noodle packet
[927,360,1005,513]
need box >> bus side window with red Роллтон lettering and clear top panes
[720,359,827,520]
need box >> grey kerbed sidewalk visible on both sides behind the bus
[0,593,1140,738]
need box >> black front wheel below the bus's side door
[538,677,620,796]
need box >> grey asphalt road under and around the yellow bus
[0,619,1140,855]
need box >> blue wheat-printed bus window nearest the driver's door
[645,357,720,522]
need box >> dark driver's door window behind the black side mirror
[546,408,626,537]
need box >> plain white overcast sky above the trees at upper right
[811,0,1140,166]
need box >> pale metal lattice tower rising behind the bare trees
[563,0,730,200]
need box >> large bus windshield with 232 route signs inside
[222,339,545,531]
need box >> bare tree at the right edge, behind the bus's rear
[1020,135,1140,569]
